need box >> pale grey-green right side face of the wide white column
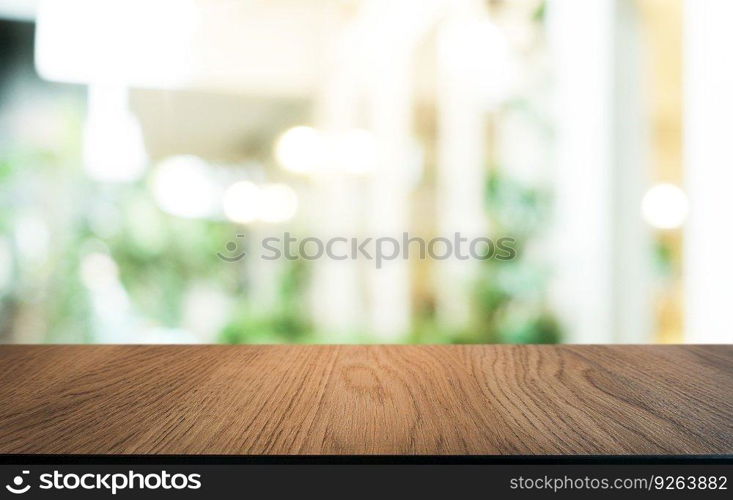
[610,0,654,344]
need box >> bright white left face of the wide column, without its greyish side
[547,0,614,343]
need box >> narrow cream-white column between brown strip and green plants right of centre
[435,6,498,328]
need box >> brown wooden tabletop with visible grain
[0,345,733,455]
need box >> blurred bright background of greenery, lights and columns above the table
[0,0,733,343]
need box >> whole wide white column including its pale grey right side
[548,0,652,343]
